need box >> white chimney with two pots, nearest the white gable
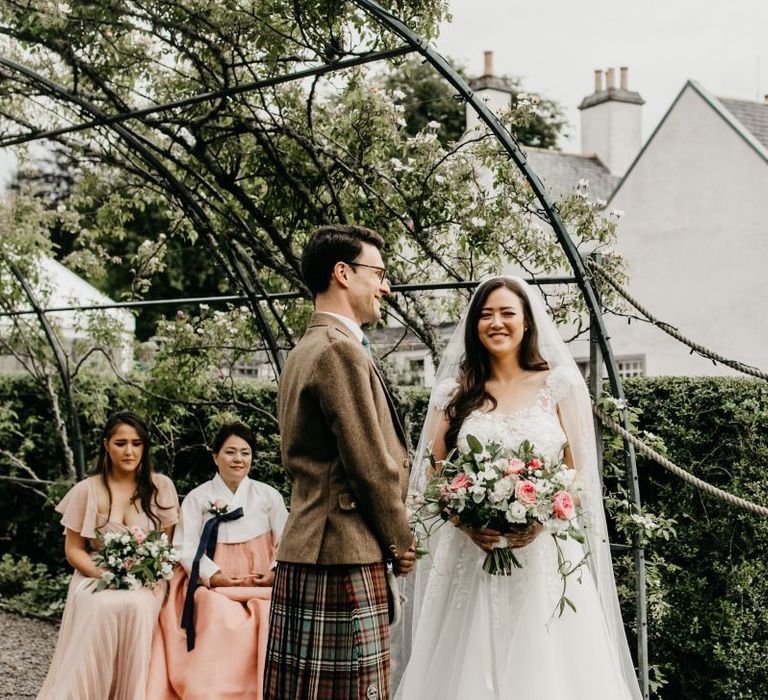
[579,66,645,175]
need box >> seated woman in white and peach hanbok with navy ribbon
[147,422,288,700]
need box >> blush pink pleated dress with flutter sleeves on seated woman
[37,474,179,700]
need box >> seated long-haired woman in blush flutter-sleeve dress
[37,411,179,700]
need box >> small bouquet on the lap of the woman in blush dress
[94,526,179,591]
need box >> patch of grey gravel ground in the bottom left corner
[0,610,59,700]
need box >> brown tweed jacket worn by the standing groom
[277,313,412,565]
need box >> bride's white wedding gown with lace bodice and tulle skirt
[395,368,632,700]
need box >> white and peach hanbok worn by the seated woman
[147,475,288,700]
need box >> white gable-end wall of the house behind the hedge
[607,85,768,375]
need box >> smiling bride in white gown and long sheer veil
[393,277,641,700]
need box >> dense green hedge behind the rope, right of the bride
[624,377,768,700]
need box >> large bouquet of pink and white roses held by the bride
[413,435,588,615]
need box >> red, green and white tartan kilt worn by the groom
[264,562,390,700]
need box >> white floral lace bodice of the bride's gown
[457,369,570,461]
